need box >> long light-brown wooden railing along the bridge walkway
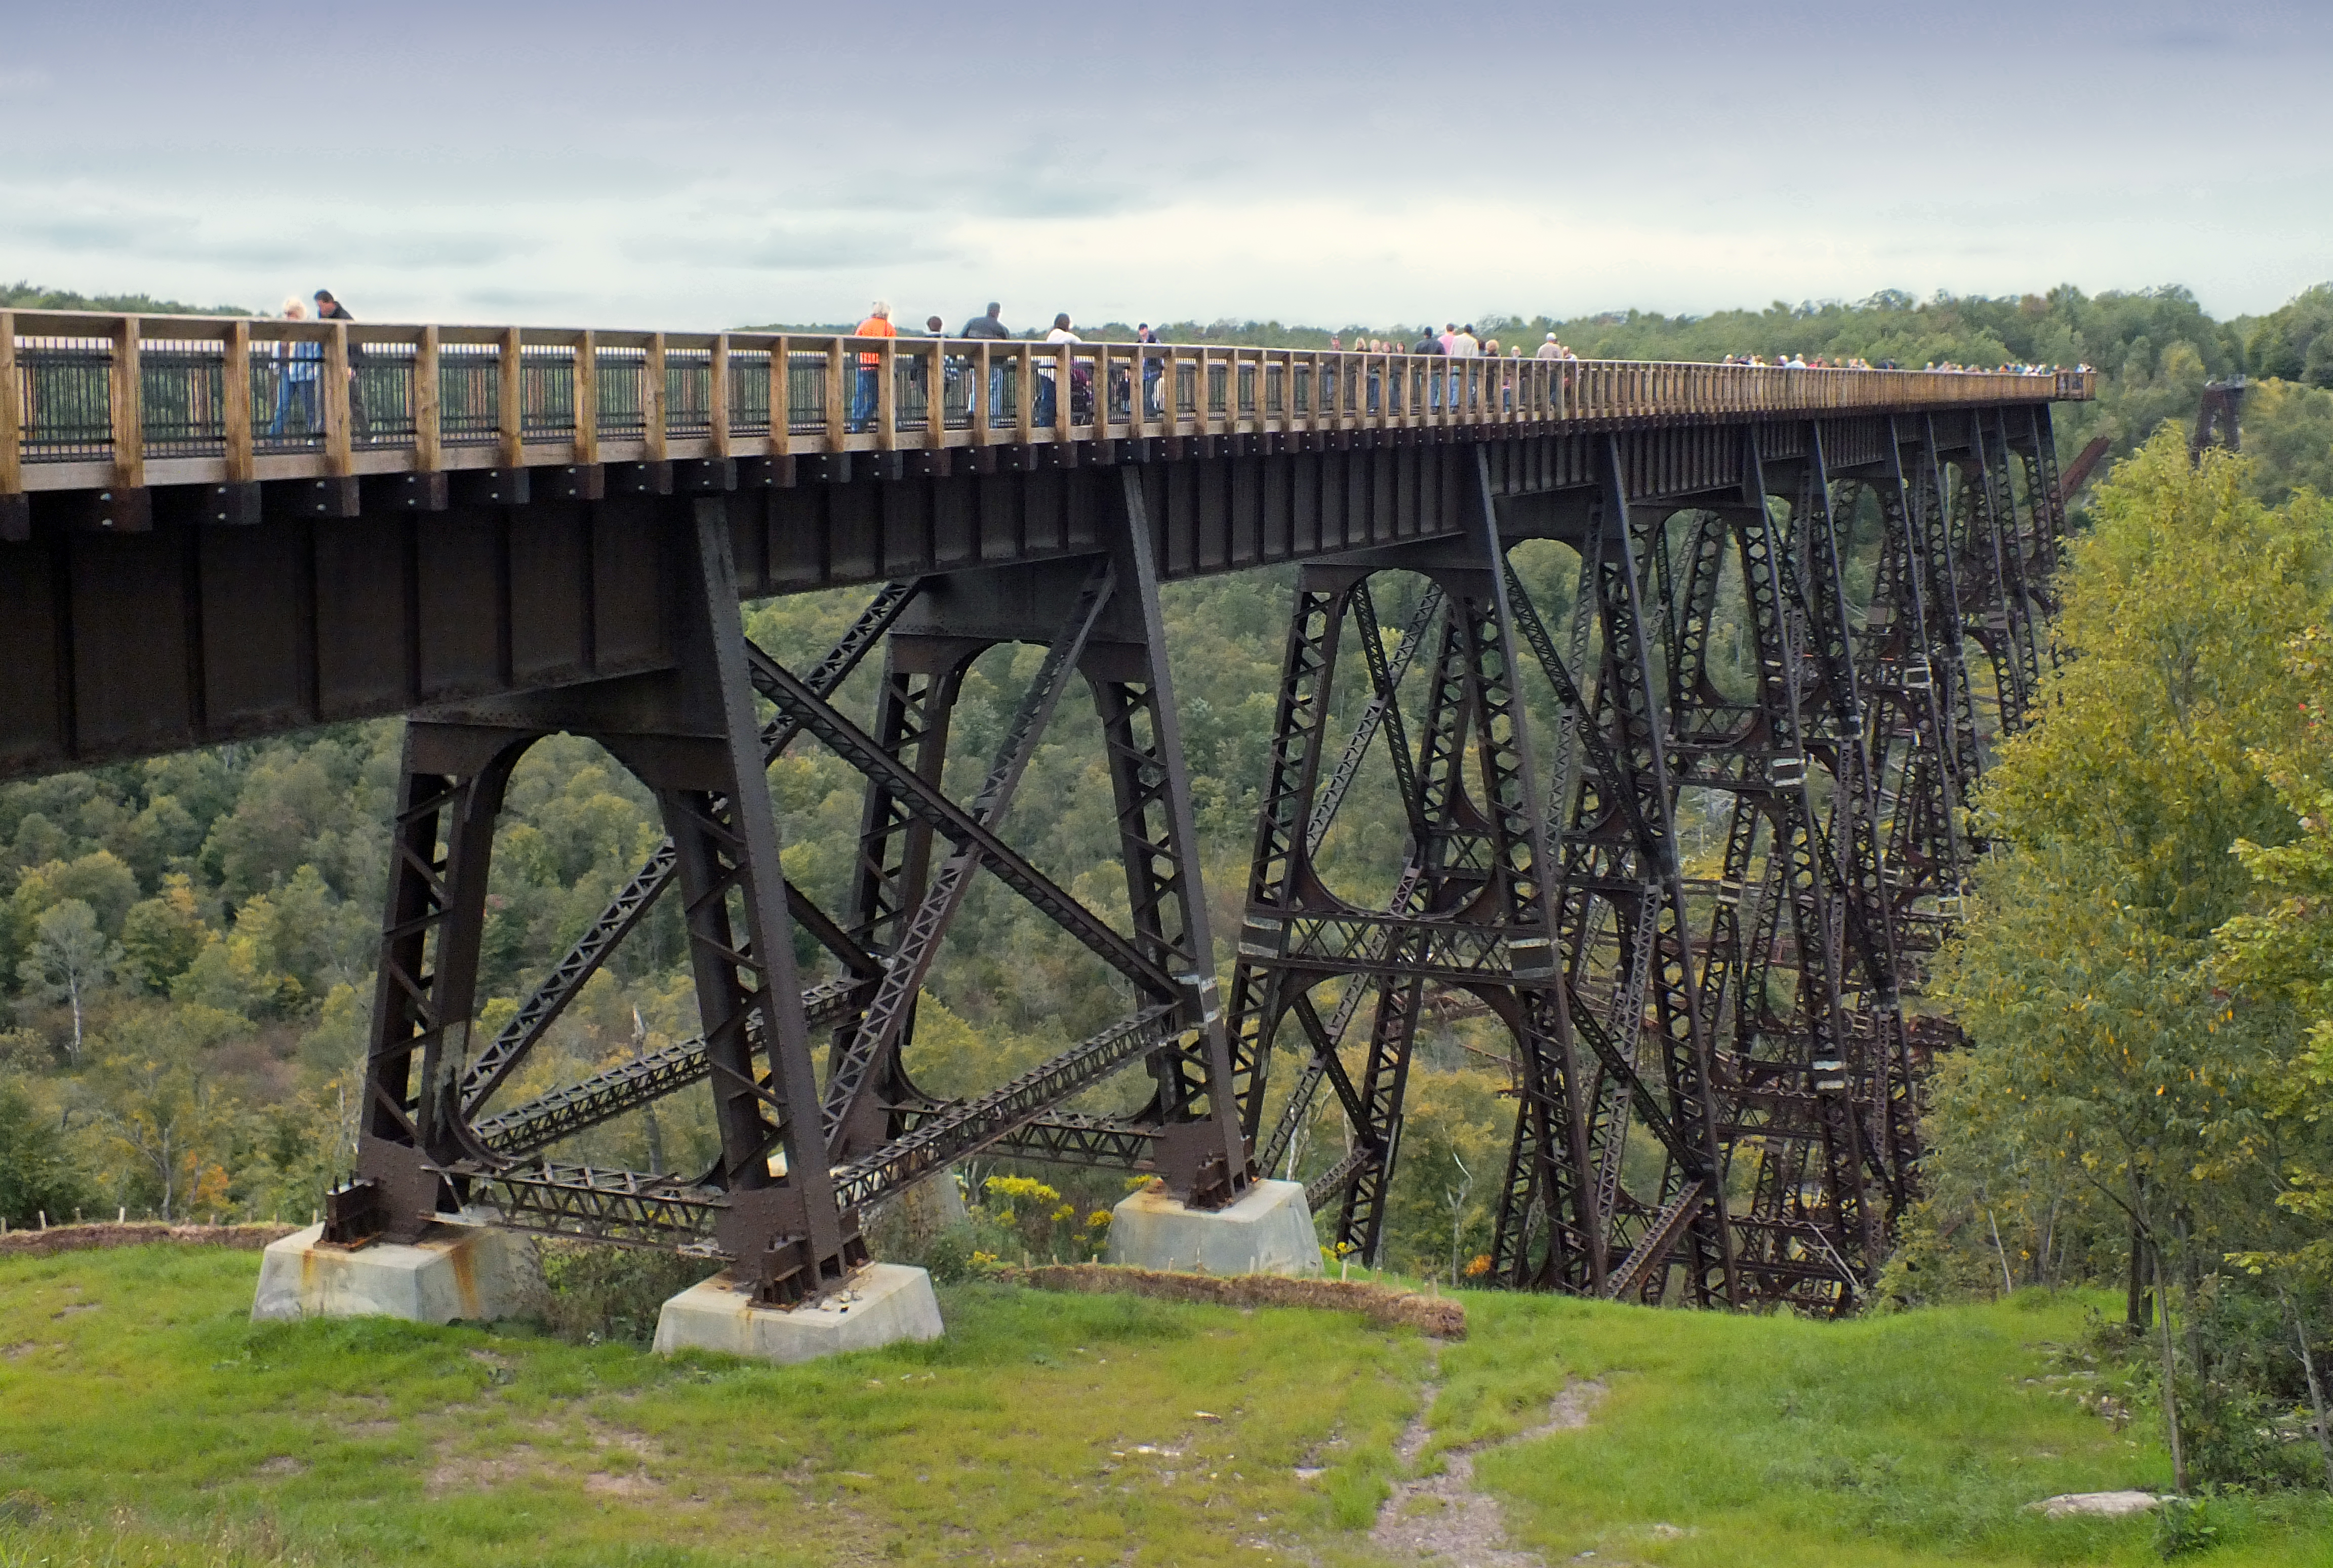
[0,310,2095,497]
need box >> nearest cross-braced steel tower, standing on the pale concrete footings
[329,476,1248,1304]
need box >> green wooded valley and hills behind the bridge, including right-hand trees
[0,285,2333,1472]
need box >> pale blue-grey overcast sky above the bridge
[0,0,2333,329]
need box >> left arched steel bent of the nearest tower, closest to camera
[331,504,866,1300]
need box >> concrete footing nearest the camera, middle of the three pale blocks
[656,1262,943,1362]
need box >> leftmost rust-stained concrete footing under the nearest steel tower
[252,1225,537,1323]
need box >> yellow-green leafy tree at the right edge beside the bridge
[1897,432,2333,1479]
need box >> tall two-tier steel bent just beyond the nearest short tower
[1232,448,1603,1281]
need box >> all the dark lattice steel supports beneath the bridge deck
[305,394,2062,1309]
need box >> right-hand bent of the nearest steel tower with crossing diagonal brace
[774,474,1248,1204]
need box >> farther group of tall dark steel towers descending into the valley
[1232,411,2062,1311]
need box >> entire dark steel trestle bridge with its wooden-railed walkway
[0,313,2093,1309]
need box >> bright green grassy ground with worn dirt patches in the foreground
[0,1249,2333,1568]
